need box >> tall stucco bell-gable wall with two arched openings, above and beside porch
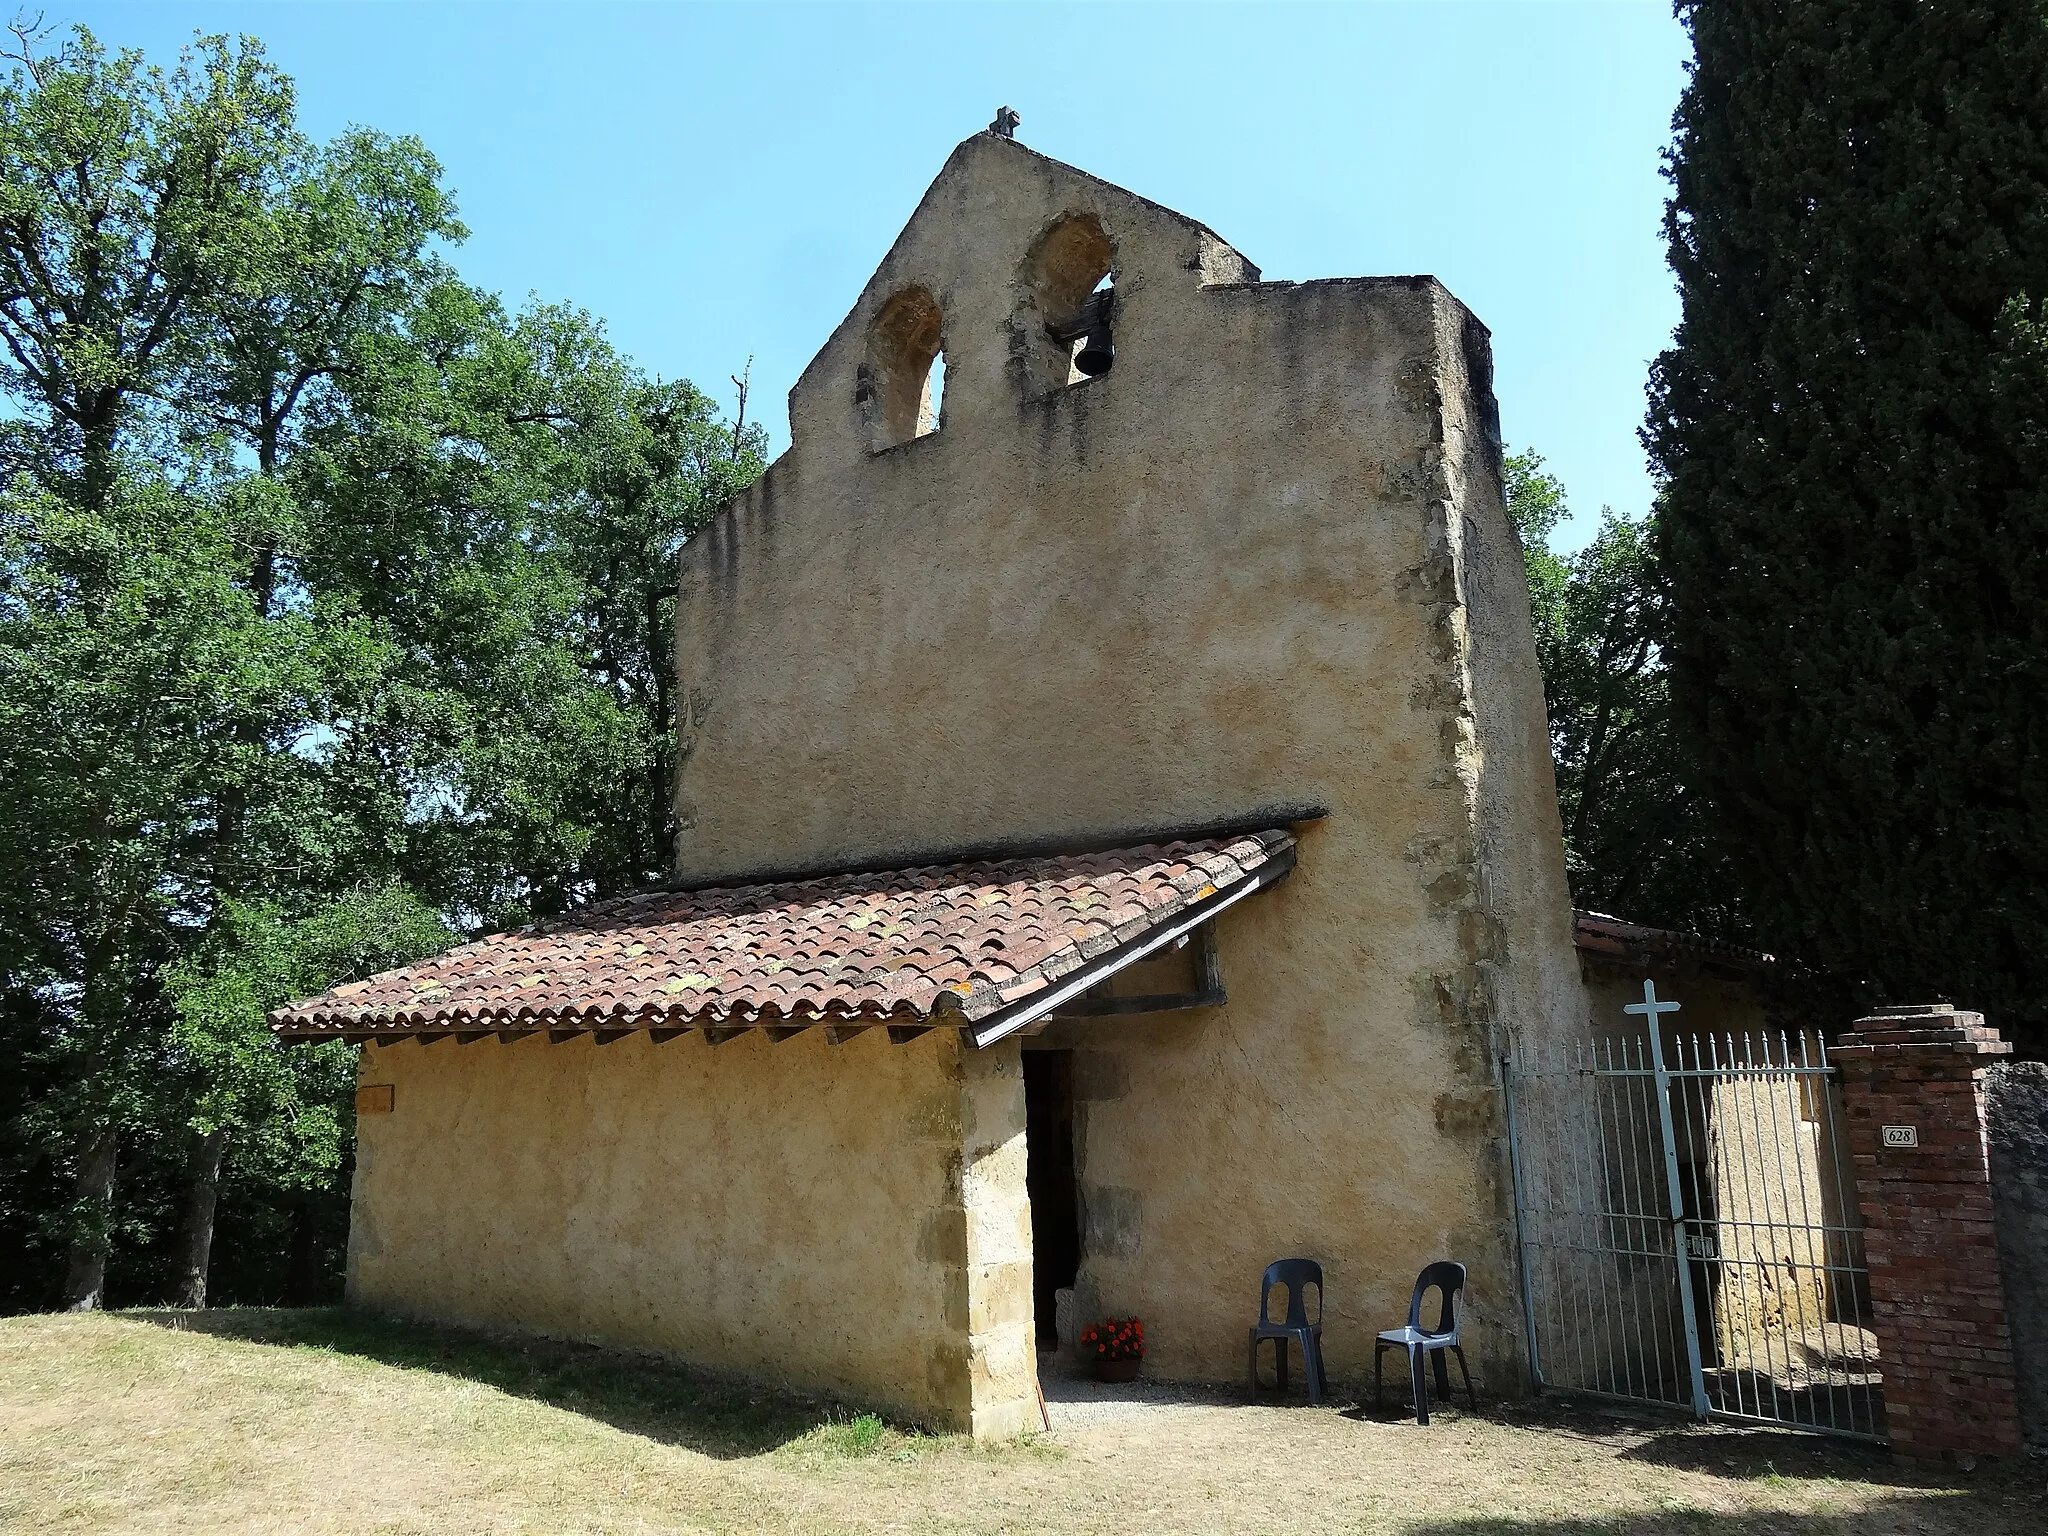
[676,137,1585,1389]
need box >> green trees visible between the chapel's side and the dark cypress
[1503,453,1743,936]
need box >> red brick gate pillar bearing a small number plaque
[1829,1004,2021,1460]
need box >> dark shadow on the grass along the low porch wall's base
[123,1307,880,1460]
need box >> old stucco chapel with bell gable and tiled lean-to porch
[274,133,1585,1436]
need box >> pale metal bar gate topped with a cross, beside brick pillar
[1501,983,1884,1438]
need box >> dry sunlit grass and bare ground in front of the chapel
[0,1311,2048,1536]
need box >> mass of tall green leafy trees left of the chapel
[0,29,766,1305]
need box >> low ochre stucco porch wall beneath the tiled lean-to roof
[348,1030,1036,1434]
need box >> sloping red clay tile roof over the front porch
[270,829,1294,1036]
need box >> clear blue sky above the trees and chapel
[72,0,1688,545]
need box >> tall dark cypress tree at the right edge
[1645,0,2048,1055]
